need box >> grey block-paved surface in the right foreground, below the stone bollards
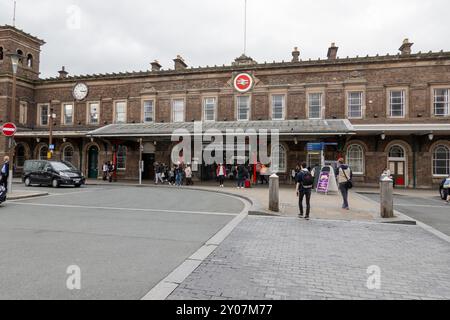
[168,216,450,300]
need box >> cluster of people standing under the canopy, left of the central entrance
[154,162,194,187]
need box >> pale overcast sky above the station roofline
[0,0,450,77]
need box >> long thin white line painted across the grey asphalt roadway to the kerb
[8,201,237,216]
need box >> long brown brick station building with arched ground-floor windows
[0,26,450,188]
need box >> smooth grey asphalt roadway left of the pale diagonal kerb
[0,186,245,299]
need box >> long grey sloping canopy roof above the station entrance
[88,120,354,137]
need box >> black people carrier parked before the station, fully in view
[22,160,86,188]
